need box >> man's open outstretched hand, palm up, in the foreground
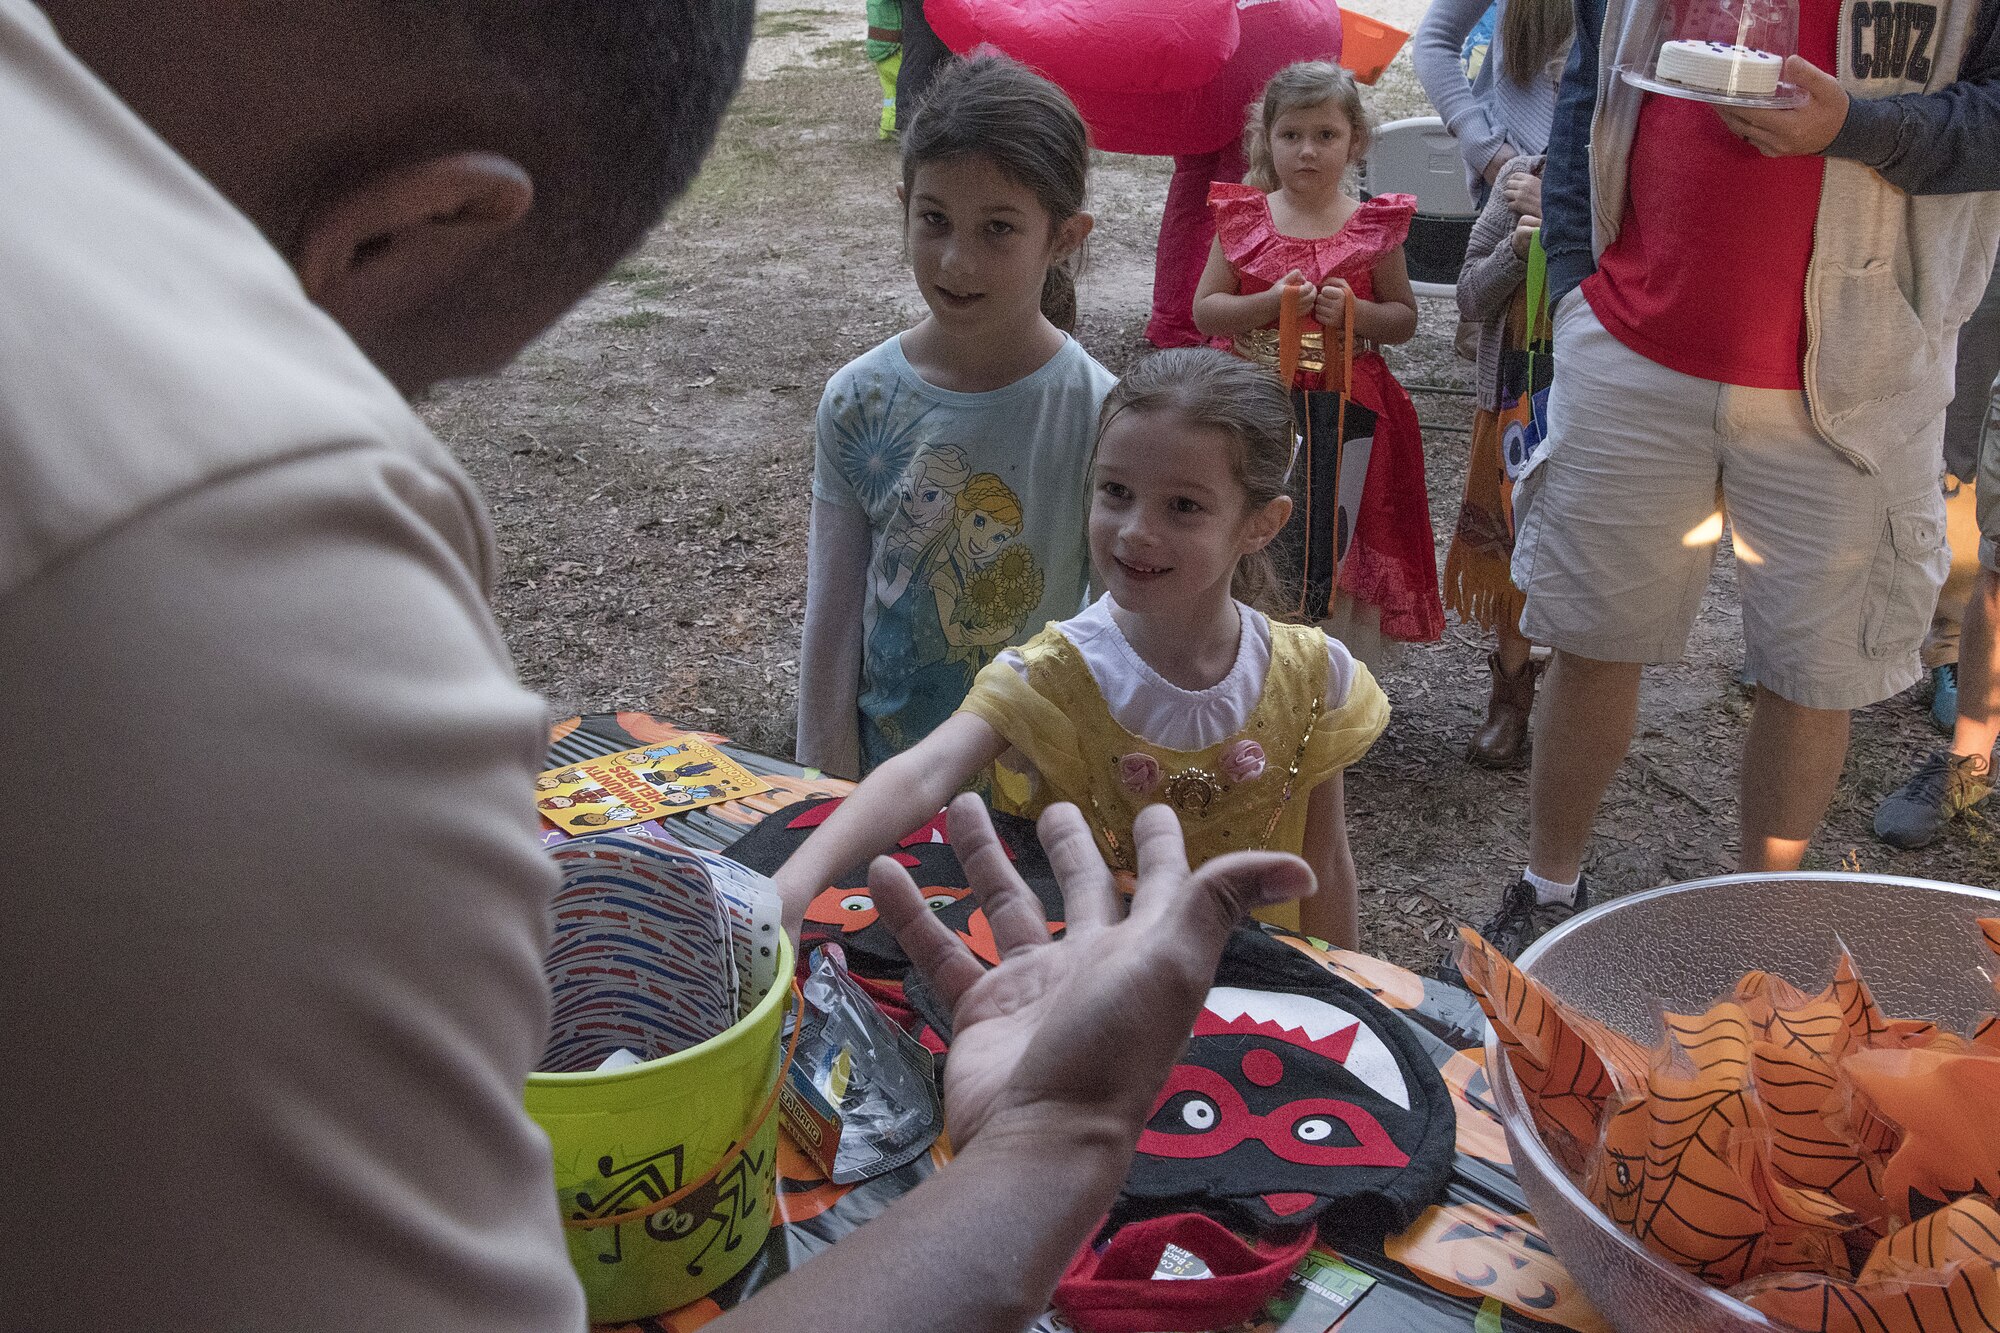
[868,795,1314,1149]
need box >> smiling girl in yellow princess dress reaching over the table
[776,348,1388,949]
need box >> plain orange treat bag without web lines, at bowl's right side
[1844,1051,2000,1219]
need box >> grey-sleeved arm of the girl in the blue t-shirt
[798,500,868,779]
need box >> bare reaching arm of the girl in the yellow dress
[772,713,1006,941]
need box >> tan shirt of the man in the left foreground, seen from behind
[0,0,582,1333]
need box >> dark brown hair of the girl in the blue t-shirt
[902,56,1090,332]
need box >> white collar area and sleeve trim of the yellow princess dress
[998,592,1354,751]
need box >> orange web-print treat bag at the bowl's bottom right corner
[1736,1199,2000,1333]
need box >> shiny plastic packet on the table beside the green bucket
[780,945,944,1185]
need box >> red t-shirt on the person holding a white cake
[1582,0,1840,388]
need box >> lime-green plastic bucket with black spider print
[528,928,792,1323]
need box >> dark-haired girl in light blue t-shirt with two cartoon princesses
[798,56,1112,777]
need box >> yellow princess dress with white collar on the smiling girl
[960,596,1388,929]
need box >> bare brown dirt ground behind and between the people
[424,6,2000,967]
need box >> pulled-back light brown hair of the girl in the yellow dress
[1098,346,1298,610]
